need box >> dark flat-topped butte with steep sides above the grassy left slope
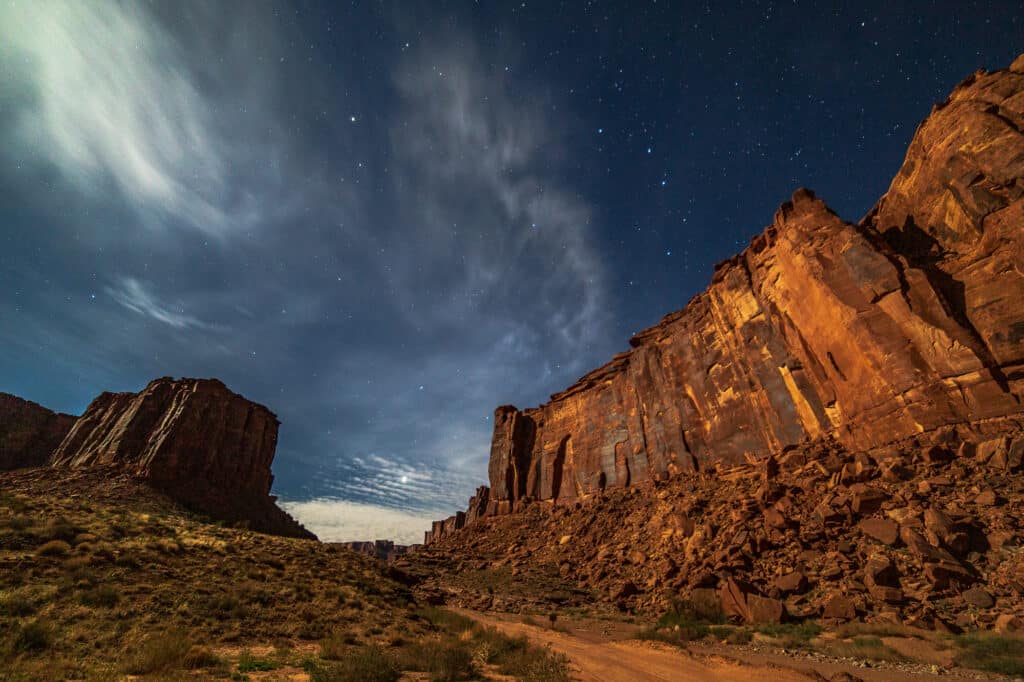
[0,377,313,538]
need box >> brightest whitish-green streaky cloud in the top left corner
[0,0,230,232]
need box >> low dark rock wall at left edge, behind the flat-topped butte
[0,393,75,470]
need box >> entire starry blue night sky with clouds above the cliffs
[0,0,1024,542]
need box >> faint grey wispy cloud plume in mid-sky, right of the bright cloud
[392,45,606,355]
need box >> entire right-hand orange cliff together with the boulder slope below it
[408,55,1024,630]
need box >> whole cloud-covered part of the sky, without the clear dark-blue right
[0,0,608,541]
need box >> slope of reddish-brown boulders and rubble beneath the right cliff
[395,431,1024,670]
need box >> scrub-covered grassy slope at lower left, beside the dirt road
[0,468,567,682]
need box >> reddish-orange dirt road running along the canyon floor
[459,610,946,682]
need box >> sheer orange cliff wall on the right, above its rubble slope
[428,55,1024,542]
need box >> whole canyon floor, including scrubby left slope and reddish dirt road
[0,458,1024,682]
